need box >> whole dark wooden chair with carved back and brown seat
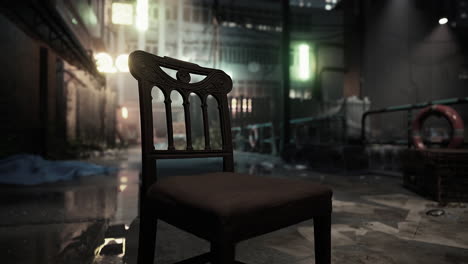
[129,51,332,264]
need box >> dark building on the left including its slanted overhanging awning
[0,0,116,157]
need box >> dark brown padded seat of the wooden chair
[147,172,332,241]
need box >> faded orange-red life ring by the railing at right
[412,105,464,149]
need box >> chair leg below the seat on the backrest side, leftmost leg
[137,210,158,264]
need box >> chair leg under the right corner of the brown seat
[314,213,331,264]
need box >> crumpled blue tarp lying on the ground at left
[0,154,115,185]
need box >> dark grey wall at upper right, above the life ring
[362,0,468,109]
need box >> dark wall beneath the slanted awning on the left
[0,7,117,159]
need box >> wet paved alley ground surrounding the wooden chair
[0,148,468,264]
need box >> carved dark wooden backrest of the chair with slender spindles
[129,51,233,191]
